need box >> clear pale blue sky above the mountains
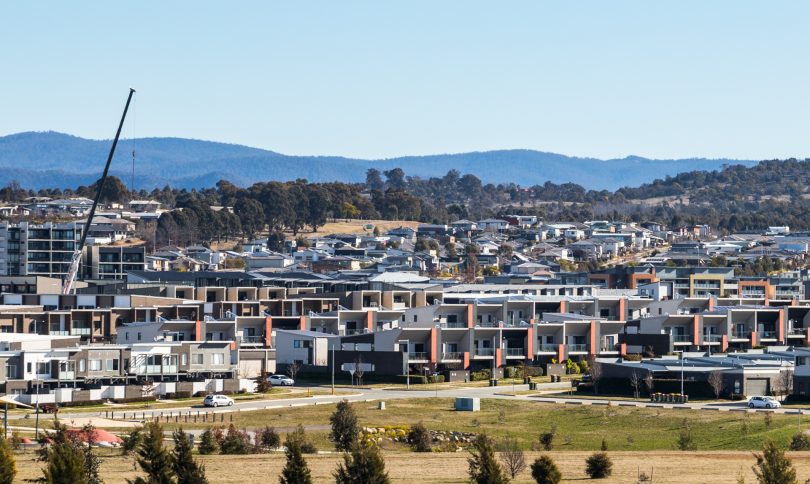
[0,0,810,159]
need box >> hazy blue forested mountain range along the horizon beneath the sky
[0,131,757,190]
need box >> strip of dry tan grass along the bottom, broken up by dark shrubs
[12,451,810,484]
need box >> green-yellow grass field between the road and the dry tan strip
[150,398,810,451]
